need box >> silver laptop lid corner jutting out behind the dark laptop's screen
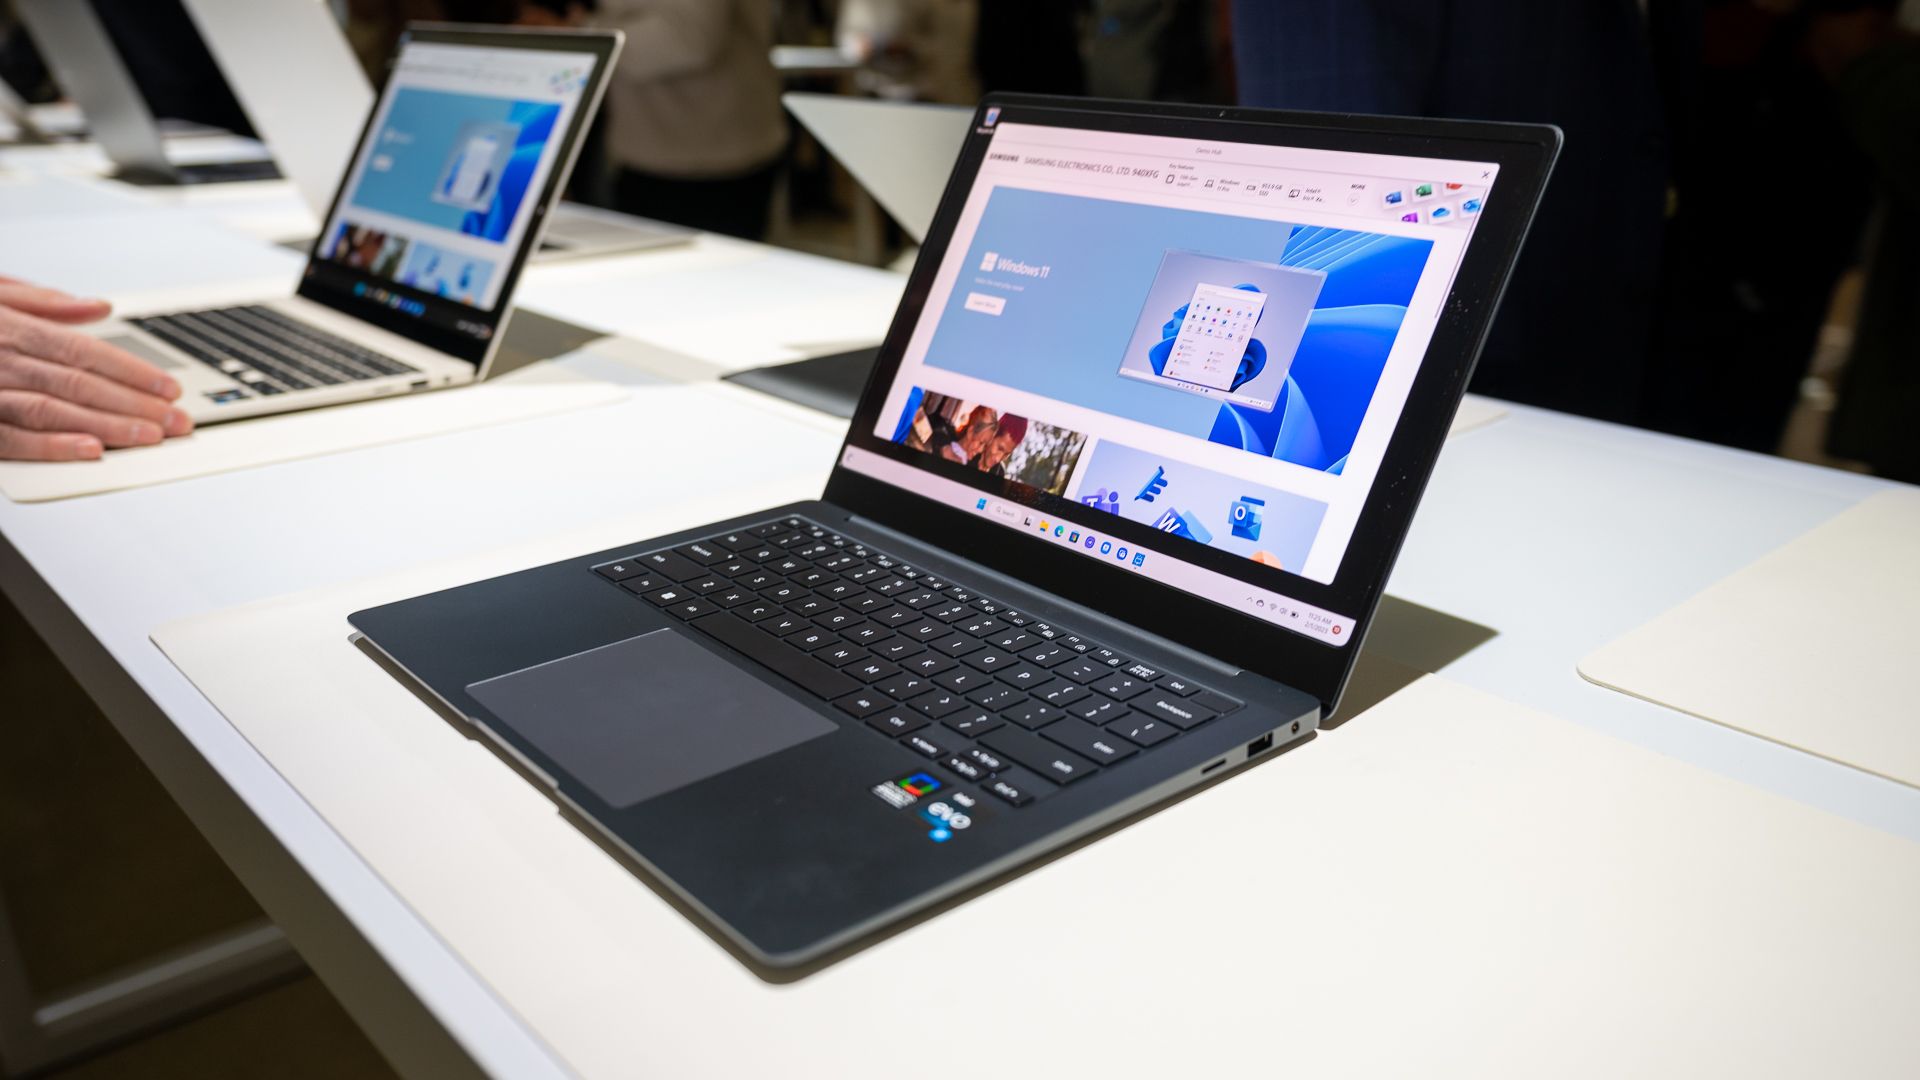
[780,94,973,244]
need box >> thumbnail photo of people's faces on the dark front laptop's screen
[893,386,1087,496]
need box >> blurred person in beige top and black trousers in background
[591,0,787,240]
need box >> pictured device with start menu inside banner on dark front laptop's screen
[1119,252,1327,413]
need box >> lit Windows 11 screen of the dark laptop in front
[843,110,1498,646]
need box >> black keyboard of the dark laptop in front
[593,517,1240,807]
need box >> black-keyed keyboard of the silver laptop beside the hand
[129,306,417,402]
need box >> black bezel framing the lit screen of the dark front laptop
[824,94,1559,711]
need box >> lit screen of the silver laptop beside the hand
[307,35,599,361]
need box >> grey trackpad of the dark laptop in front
[467,628,837,807]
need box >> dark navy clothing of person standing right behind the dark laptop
[1233,0,1667,423]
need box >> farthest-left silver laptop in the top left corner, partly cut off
[13,0,278,184]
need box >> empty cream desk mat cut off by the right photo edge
[1580,488,1920,788]
